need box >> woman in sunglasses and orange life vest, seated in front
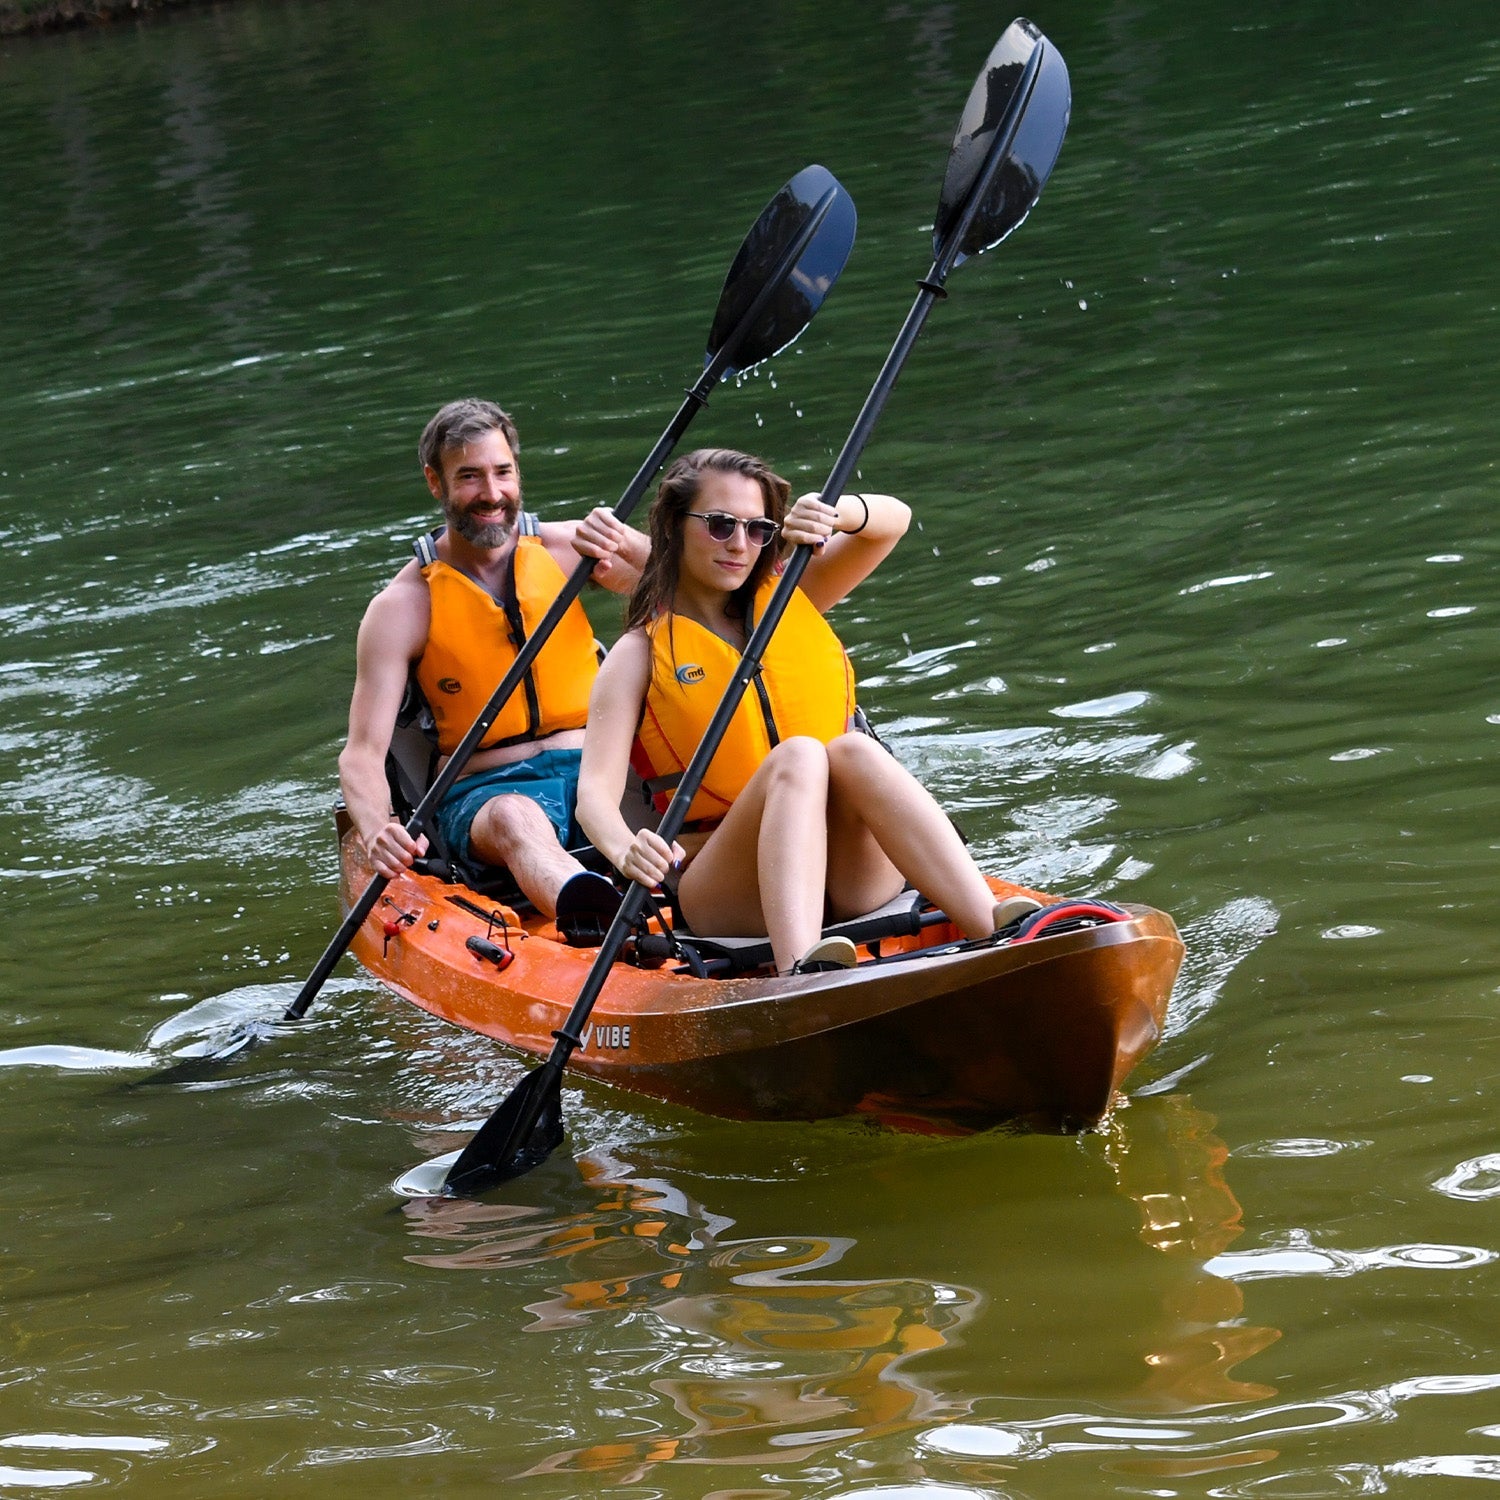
[578,449,1031,974]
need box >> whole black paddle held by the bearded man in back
[194,167,855,1062]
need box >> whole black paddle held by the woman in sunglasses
[443,21,1071,1193]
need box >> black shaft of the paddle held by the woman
[515,58,1041,1110]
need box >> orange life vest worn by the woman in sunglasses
[632,578,855,822]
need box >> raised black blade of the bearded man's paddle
[704,167,857,380]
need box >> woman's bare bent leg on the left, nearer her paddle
[677,737,828,971]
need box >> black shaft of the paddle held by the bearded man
[282,188,839,1022]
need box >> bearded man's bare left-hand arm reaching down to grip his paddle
[339,576,428,878]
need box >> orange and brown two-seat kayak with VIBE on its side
[339,813,1184,1131]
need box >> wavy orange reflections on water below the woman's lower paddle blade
[408,1152,980,1484]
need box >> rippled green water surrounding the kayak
[0,0,1500,1500]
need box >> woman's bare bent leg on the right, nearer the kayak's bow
[827,734,995,938]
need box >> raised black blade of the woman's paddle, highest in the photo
[933,20,1073,266]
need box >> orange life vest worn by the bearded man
[414,515,599,755]
